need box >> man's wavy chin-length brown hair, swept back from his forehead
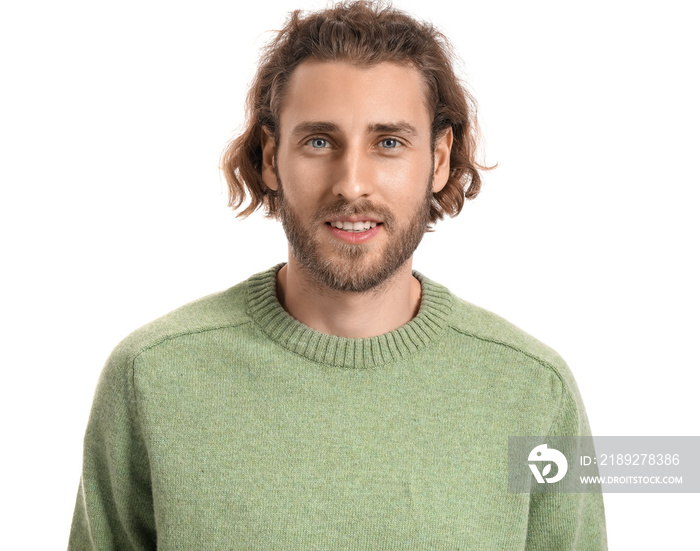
[221,1,491,223]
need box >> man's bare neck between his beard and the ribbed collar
[277,253,421,338]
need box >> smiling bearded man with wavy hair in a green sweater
[69,3,606,550]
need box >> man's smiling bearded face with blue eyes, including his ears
[263,61,452,292]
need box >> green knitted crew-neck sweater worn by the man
[69,264,606,551]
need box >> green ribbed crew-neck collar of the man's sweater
[247,262,453,368]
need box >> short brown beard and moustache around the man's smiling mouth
[277,170,433,293]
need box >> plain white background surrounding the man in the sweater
[0,0,700,550]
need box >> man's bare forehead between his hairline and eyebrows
[280,60,432,133]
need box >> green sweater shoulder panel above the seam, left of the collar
[112,279,250,360]
